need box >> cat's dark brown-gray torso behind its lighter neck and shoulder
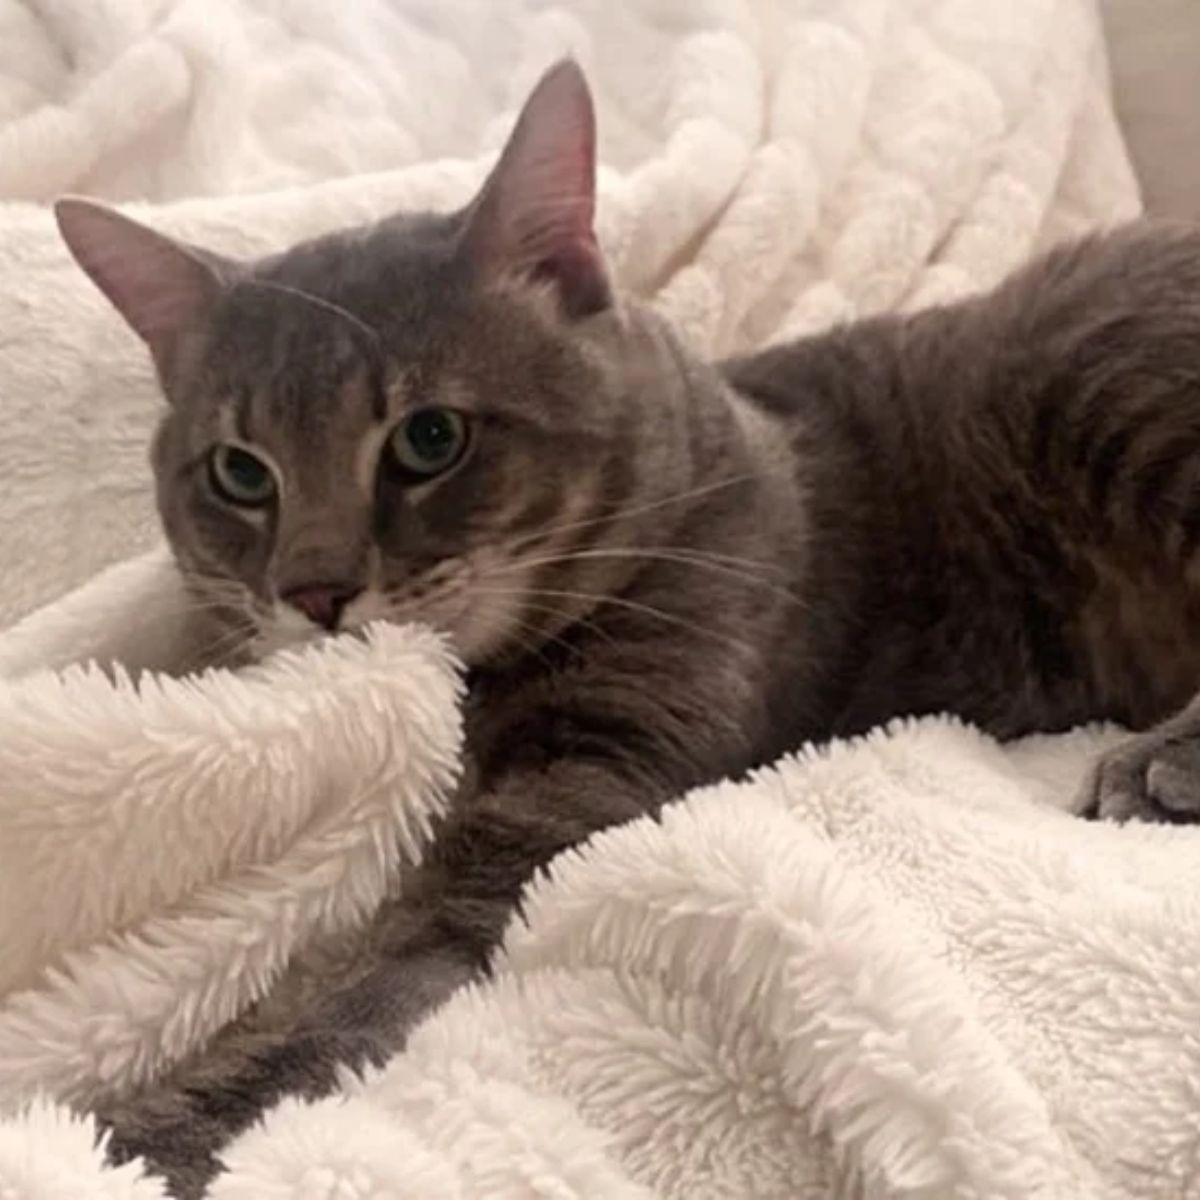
[724,222,1200,733]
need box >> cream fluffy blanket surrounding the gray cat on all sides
[0,0,1180,1200]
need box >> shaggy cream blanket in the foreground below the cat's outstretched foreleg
[9,705,1200,1200]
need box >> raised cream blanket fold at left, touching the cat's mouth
[0,553,461,1108]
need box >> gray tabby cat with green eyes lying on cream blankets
[58,64,1200,1196]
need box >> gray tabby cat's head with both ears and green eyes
[56,62,689,662]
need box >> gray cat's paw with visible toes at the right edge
[1080,730,1200,824]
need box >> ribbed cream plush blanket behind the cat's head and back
[0,0,1138,623]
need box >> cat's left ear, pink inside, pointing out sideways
[54,197,227,376]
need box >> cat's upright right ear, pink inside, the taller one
[462,59,612,317]
